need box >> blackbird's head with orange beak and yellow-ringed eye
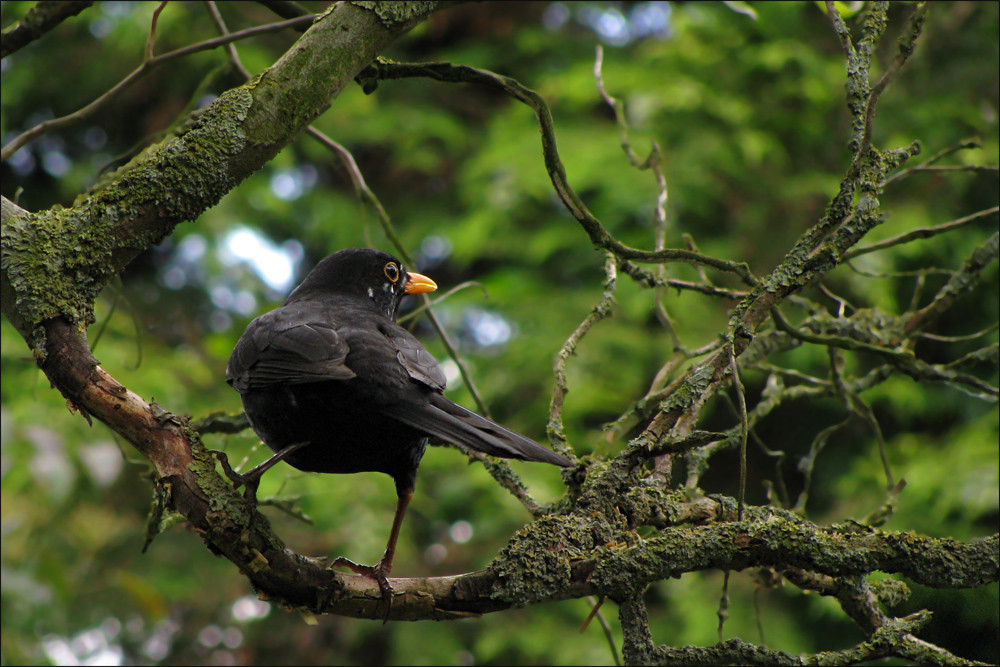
[285,248,437,320]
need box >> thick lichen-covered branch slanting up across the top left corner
[2,3,439,352]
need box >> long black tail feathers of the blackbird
[391,392,573,468]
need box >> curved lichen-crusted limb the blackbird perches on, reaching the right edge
[19,312,1000,620]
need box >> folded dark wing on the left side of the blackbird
[226,306,355,393]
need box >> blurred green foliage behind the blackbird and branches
[0,2,1000,665]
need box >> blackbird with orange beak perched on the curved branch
[224,248,573,616]
